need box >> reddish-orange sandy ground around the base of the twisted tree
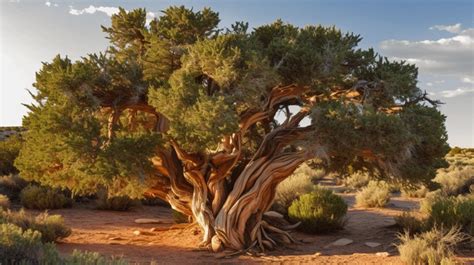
[31,187,474,264]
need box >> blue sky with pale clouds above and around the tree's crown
[0,0,474,147]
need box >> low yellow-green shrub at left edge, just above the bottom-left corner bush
[0,207,71,242]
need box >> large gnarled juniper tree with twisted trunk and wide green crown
[16,7,448,251]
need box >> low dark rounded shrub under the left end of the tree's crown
[20,185,72,210]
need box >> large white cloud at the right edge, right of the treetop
[380,24,474,80]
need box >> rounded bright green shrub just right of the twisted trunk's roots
[288,188,347,233]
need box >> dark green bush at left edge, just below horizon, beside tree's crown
[0,135,23,176]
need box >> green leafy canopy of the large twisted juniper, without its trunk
[17,6,449,200]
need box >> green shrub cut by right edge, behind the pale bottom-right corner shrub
[428,195,474,235]
